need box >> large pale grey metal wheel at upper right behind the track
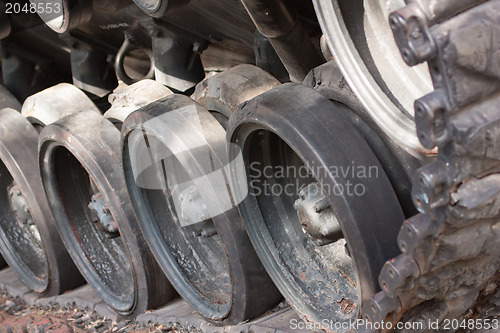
[313,0,432,156]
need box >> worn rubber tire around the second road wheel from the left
[39,111,176,318]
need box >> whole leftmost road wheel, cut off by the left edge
[0,109,83,295]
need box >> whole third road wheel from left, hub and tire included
[122,95,281,324]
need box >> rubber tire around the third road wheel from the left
[122,95,281,325]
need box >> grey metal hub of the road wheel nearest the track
[293,182,342,245]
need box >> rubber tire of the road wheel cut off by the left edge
[0,109,84,296]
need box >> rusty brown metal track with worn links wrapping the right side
[363,0,500,331]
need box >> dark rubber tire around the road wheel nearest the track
[228,84,404,323]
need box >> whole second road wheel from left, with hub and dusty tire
[39,107,175,316]
